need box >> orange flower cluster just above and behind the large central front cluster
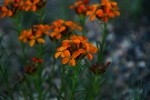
[49,19,82,40]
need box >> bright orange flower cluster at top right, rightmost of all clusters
[86,0,120,22]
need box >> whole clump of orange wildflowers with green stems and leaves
[0,0,120,100]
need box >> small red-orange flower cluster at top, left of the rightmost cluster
[70,0,89,15]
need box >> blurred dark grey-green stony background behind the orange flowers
[0,0,150,100]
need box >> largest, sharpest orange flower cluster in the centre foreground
[55,35,97,66]
